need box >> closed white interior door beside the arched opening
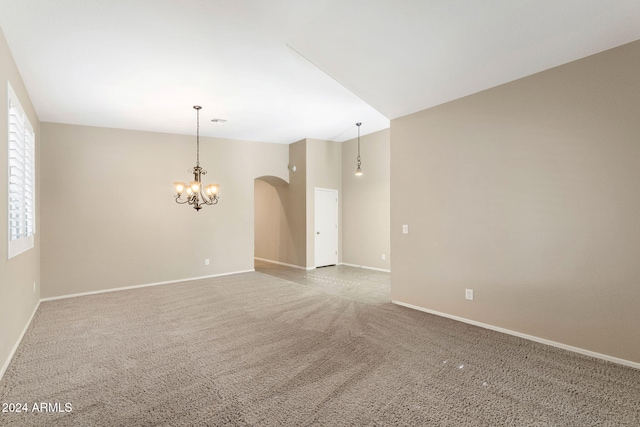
[314,188,338,267]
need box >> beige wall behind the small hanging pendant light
[342,129,391,270]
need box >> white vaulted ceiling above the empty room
[0,0,640,143]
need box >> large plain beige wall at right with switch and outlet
[391,42,640,362]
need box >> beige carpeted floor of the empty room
[0,265,640,427]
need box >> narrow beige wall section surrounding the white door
[306,138,342,268]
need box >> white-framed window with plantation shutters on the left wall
[7,81,36,259]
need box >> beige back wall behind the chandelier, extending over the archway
[41,123,288,297]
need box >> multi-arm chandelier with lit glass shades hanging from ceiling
[173,105,220,211]
